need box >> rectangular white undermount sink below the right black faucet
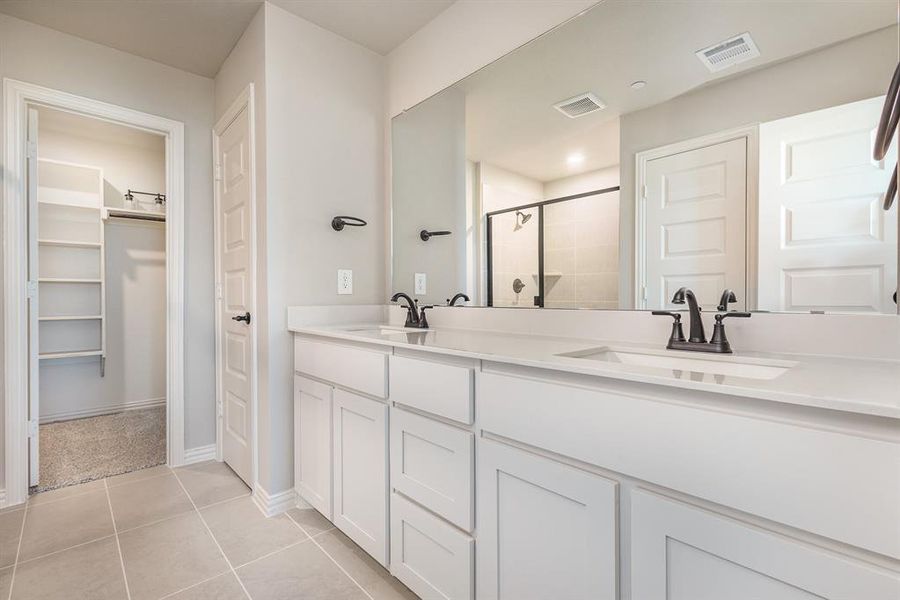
[557,346,797,379]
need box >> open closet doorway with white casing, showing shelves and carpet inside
[3,80,184,504]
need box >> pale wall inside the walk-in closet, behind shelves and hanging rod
[38,122,166,420]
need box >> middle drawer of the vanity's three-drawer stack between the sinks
[391,407,475,531]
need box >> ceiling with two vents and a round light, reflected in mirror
[454,0,897,182]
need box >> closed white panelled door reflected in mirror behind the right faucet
[642,138,747,310]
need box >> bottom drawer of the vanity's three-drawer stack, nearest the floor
[391,493,475,600]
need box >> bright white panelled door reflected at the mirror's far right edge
[759,97,897,313]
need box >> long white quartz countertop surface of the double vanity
[290,323,900,418]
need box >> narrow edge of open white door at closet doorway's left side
[26,108,40,485]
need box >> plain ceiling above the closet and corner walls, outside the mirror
[0,0,453,77]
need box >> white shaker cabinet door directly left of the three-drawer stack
[332,389,388,567]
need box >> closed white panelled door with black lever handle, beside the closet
[216,107,256,486]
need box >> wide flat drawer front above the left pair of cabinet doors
[294,336,388,398]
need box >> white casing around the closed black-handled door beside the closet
[212,83,260,492]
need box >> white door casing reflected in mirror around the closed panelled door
[632,123,759,310]
